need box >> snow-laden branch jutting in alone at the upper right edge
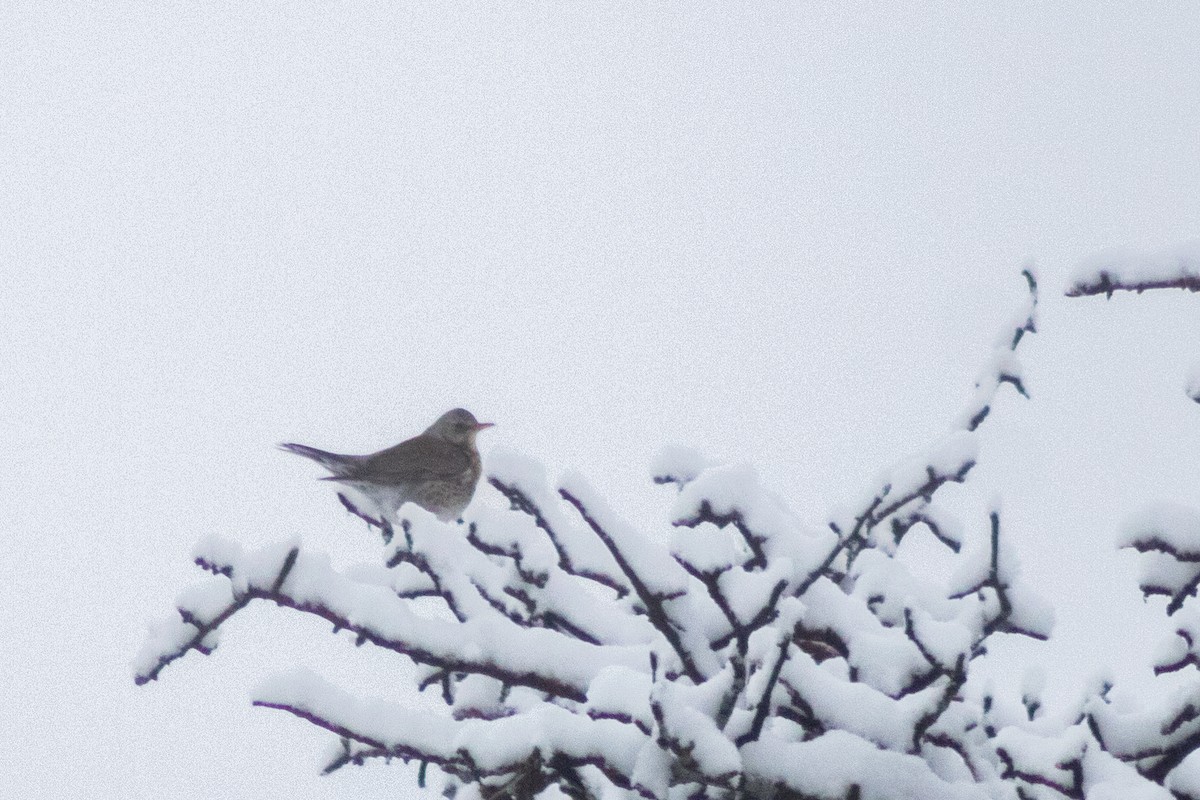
[1067,240,1200,297]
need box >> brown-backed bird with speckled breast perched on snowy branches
[280,408,494,541]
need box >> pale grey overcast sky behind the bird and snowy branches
[0,0,1200,800]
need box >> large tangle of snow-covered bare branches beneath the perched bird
[134,270,1142,800]
